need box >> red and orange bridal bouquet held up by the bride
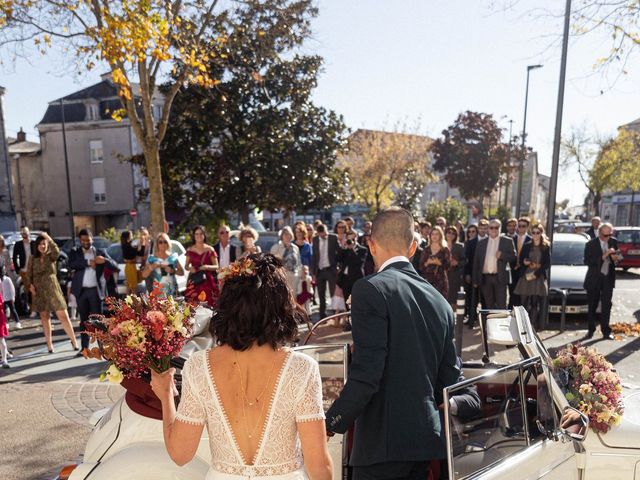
[90,288,194,383]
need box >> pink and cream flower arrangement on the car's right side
[553,345,624,433]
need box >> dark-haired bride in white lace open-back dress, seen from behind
[151,254,332,480]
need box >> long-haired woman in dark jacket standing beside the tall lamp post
[513,224,551,328]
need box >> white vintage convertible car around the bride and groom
[58,307,640,480]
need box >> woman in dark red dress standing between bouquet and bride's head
[185,225,220,307]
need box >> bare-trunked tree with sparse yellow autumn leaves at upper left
[0,0,225,232]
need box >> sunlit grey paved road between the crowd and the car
[0,270,640,480]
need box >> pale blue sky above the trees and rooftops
[0,0,640,203]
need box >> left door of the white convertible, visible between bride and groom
[295,344,350,479]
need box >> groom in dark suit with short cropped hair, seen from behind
[326,207,460,480]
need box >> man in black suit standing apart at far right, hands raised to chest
[584,223,620,340]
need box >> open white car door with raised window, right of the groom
[444,357,579,480]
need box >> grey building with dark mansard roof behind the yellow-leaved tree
[37,75,154,235]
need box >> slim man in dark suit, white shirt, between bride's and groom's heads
[311,224,346,318]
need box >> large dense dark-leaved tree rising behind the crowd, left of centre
[142,0,347,223]
